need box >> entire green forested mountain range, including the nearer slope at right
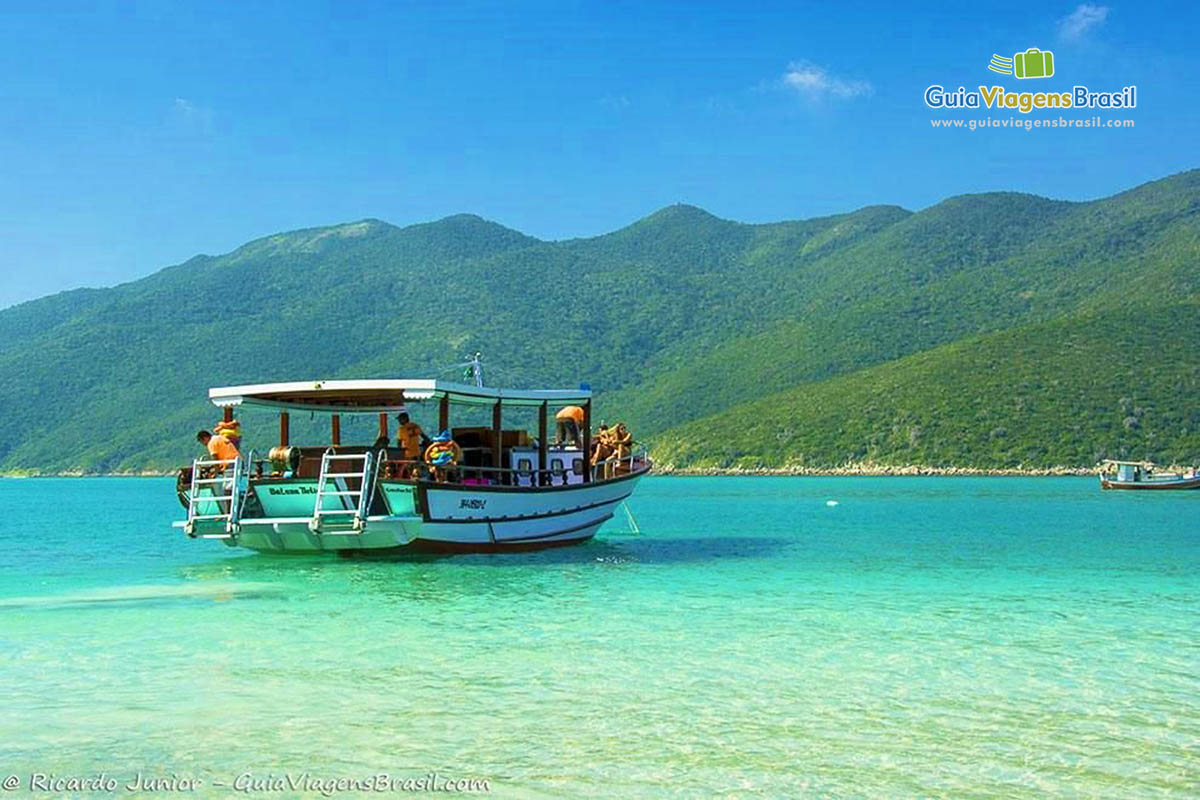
[0,170,1200,471]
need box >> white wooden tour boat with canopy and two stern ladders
[175,379,650,553]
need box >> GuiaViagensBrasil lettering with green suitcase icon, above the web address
[925,47,1138,114]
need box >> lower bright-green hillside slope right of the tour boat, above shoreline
[655,300,1200,468]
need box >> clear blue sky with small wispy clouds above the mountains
[0,0,1200,307]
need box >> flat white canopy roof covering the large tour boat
[209,378,592,414]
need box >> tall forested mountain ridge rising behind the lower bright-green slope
[0,170,1200,471]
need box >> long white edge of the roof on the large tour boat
[209,378,592,411]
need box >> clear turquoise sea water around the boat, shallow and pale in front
[0,477,1200,798]
